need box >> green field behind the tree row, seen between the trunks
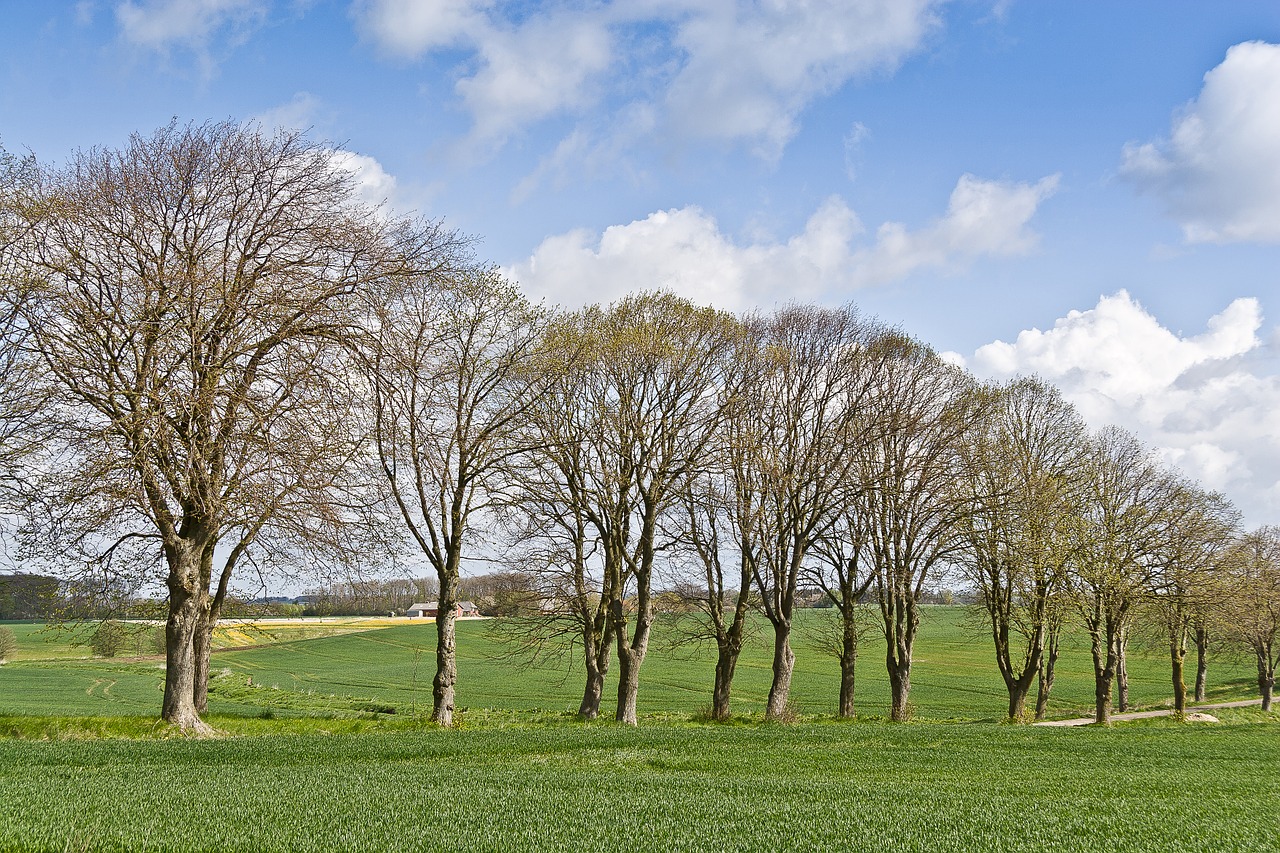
[0,607,1256,720]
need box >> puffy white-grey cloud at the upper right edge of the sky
[1121,41,1280,243]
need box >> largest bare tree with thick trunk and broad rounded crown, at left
[9,123,442,729]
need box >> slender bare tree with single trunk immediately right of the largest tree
[367,265,547,726]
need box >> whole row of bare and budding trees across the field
[0,123,1277,729]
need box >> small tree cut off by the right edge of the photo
[1228,526,1280,711]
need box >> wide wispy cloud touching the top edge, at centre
[353,0,942,156]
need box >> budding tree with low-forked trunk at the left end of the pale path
[957,379,1087,721]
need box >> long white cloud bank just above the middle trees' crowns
[508,175,1056,309]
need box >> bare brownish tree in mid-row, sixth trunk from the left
[727,306,893,720]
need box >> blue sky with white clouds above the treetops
[0,0,1280,526]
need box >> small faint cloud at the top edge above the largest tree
[115,0,270,50]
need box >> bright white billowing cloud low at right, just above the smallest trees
[951,291,1280,524]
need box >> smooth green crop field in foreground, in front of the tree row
[0,712,1280,852]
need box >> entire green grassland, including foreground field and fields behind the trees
[0,608,1280,850]
